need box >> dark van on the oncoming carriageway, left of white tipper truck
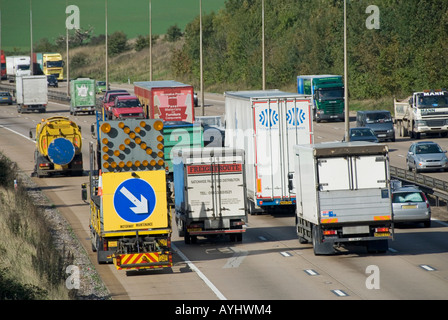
[356,110,395,142]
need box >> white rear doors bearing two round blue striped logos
[253,97,312,205]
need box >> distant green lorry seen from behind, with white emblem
[70,78,96,116]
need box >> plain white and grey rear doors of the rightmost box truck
[318,155,391,223]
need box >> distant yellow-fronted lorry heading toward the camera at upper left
[33,52,64,81]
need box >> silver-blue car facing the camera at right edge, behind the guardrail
[406,141,448,172]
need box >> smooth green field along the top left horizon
[0,0,225,51]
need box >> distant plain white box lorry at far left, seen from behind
[16,76,48,113]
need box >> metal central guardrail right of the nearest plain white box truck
[389,166,448,202]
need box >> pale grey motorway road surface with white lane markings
[0,83,448,305]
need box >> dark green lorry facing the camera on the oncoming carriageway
[297,75,345,122]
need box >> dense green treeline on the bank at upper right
[172,0,448,99]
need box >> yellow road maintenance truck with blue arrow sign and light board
[86,113,173,270]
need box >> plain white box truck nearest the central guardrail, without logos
[294,141,393,255]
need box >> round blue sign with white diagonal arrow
[114,178,157,223]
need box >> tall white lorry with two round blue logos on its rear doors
[225,90,313,214]
